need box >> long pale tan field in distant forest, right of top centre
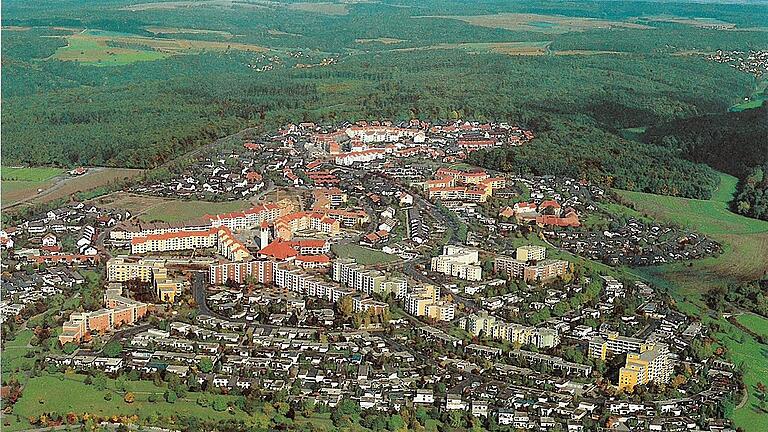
[414,13,652,34]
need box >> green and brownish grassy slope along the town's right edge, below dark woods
[620,174,768,432]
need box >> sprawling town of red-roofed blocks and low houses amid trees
[0,120,740,432]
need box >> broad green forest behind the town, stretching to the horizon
[2,0,768,202]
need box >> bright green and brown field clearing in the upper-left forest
[53,30,268,66]
